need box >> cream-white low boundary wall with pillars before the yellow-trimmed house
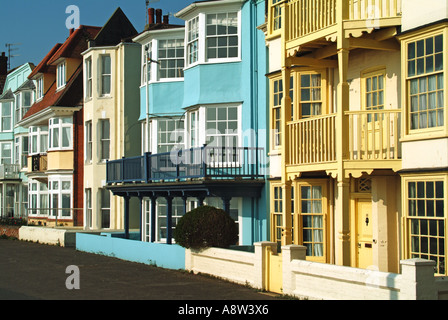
[185,242,448,300]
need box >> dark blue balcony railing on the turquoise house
[107,146,266,183]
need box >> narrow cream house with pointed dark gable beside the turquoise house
[82,8,141,230]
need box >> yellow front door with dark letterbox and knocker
[356,199,373,269]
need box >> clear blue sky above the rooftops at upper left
[0,0,195,68]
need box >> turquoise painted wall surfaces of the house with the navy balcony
[136,0,269,245]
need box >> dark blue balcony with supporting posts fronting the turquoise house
[106,146,267,244]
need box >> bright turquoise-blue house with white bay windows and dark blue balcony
[107,0,269,245]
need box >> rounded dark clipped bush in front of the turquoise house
[173,206,238,249]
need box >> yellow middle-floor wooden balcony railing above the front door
[286,110,401,172]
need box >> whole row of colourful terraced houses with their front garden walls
[0,0,448,299]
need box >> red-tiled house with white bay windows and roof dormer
[19,26,101,226]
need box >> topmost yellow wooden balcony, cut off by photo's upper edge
[268,0,402,54]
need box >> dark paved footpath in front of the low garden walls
[0,239,292,303]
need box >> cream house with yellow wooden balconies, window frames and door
[264,0,448,275]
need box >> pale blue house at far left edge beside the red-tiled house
[0,63,35,217]
